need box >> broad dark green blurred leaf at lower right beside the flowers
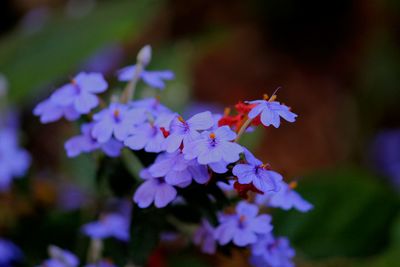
[274,169,400,258]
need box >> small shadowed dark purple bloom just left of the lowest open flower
[193,220,217,254]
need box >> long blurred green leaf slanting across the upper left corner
[0,0,162,104]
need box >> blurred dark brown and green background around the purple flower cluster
[0,0,400,267]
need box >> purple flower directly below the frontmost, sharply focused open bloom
[149,151,210,187]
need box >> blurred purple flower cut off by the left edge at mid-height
[0,128,31,191]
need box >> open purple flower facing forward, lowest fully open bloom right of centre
[215,201,272,247]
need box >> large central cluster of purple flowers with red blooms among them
[34,46,312,266]
